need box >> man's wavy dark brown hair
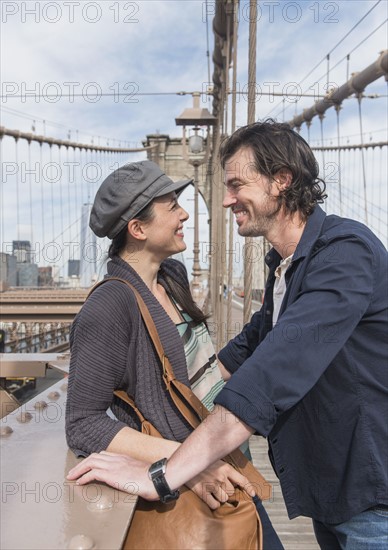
[220,118,327,219]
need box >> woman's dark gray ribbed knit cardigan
[66,257,197,456]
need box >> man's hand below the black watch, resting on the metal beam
[67,451,159,500]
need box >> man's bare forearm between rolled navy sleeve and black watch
[166,405,254,490]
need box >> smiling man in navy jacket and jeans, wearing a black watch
[70,120,388,550]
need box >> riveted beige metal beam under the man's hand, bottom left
[0,354,136,550]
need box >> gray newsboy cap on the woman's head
[89,160,193,239]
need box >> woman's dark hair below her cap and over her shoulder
[108,202,208,323]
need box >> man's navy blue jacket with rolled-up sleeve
[215,207,388,523]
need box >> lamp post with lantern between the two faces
[175,92,216,299]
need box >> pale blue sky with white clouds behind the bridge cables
[0,0,388,282]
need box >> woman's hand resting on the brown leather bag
[186,460,255,510]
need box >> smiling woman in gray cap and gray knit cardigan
[66,161,280,548]
